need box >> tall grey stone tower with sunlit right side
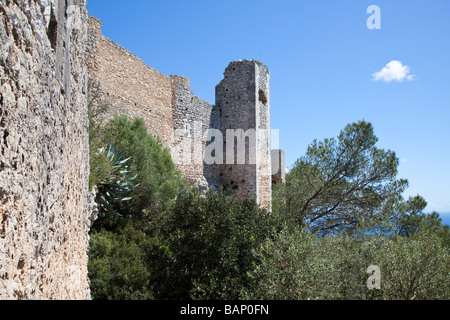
[216,60,272,210]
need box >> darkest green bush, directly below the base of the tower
[152,191,284,299]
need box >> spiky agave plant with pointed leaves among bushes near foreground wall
[96,145,139,217]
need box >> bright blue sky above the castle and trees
[88,0,450,215]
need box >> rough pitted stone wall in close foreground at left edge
[0,0,90,299]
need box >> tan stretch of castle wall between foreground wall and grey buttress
[87,16,174,148]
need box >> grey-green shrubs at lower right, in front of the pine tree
[246,219,450,300]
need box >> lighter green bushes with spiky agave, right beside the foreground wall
[88,116,186,300]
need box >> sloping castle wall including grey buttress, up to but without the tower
[87,17,217,185]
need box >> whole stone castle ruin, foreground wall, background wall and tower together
[0,0,284,300]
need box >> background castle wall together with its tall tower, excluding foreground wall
[87,17,282,209]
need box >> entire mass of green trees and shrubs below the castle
[88,102,450,300]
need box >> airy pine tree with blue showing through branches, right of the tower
[274,121,408,233]
